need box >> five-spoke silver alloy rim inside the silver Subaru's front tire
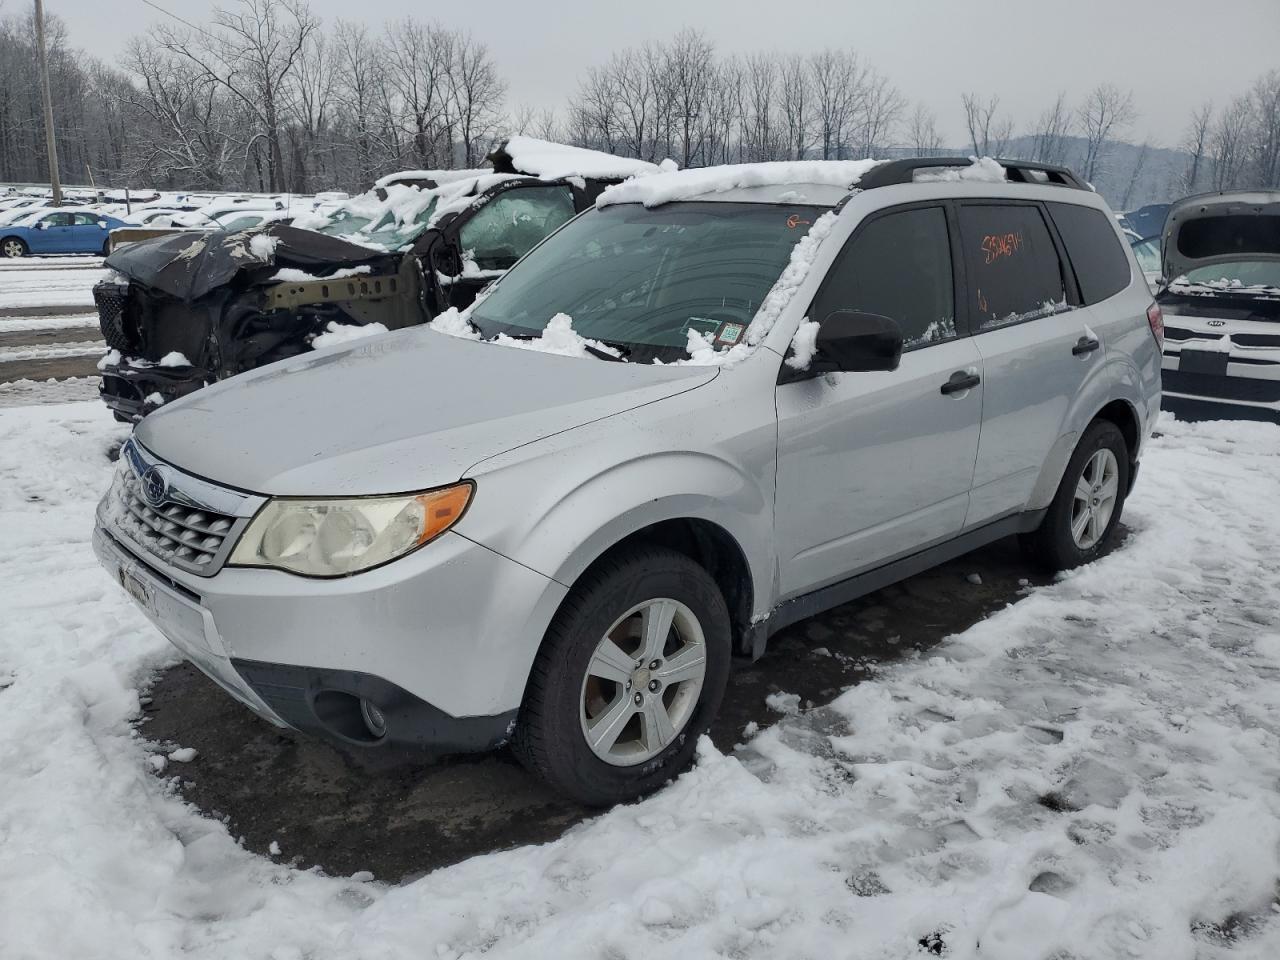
[580,598,707,767]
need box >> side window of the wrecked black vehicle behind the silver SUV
[458,186,573,270]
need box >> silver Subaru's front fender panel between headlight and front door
[456,378,777,614]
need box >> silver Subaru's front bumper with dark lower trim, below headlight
[93,509,566,754]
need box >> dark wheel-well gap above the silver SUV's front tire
[555,517,755,660]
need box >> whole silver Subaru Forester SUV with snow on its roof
[93,159,1161,804]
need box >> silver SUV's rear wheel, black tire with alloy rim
[1019,420,1130,571]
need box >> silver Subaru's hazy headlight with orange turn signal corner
[228,483,475,577]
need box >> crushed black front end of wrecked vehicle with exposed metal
[93,224,422,421]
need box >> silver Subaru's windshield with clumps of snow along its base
[470,202,823,362]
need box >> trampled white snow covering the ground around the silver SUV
[0,403,1280,960]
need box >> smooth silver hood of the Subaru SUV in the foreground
[136,326,716,497]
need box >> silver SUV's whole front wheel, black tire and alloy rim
[512,547,731,806]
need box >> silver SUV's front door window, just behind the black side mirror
[809,207,956,349]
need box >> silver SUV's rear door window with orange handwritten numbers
[960,204,1068,332]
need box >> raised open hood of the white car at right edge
[1160,191,1280,284]
